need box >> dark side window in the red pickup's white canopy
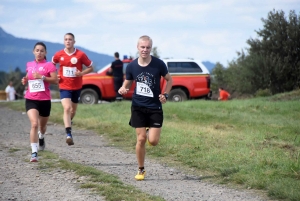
[167,62,203,73]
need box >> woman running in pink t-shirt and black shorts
[22,42,57,162]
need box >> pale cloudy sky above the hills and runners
[0,0,300,66]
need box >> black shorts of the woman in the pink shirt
[25,99,51,117]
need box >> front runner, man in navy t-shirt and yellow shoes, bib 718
[119,36,173,180]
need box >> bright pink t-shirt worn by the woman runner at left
[25,60,56,100]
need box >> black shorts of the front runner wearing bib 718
[129,106,164,128]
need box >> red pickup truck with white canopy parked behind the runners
[80,56,212,104]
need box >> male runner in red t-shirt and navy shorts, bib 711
[52,33,93,146]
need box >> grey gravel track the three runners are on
[0,105,268,201]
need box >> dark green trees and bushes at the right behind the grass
[212,10,300,96]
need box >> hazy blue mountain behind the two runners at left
[0,27,114,72]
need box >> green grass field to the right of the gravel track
[4,91,300,201]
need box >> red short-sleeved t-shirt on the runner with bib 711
[52,48,93,90]
